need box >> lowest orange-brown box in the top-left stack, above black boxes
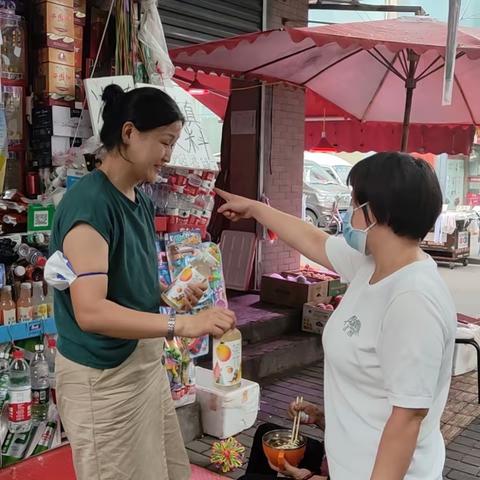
[34,62,75,101]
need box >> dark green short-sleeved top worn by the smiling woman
[50,170,160,369]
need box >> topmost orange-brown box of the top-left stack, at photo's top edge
[33,2,74,52]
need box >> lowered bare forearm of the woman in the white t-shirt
[371,409,424,480]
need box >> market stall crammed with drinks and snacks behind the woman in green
[0,0,253,472]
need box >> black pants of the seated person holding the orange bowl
[239,423,325,480]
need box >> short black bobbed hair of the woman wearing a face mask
[347,152,442,240]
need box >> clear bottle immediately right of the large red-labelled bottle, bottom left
[31,345,50,425]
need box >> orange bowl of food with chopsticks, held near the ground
[262,430,306,470]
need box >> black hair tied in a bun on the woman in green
[100,84,185,150]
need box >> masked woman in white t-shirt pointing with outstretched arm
[218,152,456,480]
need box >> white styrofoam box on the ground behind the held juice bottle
[195,367,260,439]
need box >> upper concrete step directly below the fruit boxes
[229,294,302,344]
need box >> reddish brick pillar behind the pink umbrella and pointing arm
[261,0,308,273]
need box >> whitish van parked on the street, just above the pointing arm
[303,160,351,233]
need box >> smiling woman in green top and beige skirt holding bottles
[51,85,235,480]
